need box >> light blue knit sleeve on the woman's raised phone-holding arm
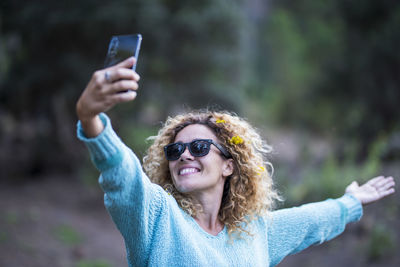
[77,114,165,266]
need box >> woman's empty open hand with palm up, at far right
[346,176,395,205]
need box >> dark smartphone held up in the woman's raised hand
[104,34,142,70]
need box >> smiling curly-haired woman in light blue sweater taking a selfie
[77,58,394,266]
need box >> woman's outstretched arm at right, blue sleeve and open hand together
[267,176,395,266]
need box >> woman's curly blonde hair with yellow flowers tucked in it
[143,110,279,236]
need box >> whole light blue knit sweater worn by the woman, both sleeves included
[78,114,362,267]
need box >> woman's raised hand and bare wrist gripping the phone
[76,57,140,138]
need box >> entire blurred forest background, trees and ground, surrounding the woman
[0,0,400,267]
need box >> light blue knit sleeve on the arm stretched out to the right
[267,194,362,266]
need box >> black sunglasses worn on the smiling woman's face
[164,139,232,161]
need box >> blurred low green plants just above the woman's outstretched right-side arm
[277,136,386,207]
